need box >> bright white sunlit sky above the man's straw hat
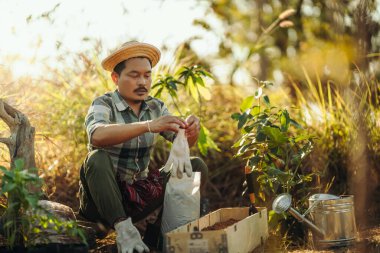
[0,0,216,76]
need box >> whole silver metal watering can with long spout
[272,193,356,248]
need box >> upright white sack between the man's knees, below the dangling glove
[161,172,201,235]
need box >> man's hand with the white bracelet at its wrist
[149,115,188,133]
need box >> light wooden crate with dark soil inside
[164,207,268,253]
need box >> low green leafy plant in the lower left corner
[0,160,86,248]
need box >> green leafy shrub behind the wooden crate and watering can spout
[232,82,314,243]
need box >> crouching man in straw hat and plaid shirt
[80,41,207,253]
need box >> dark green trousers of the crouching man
[79,150,208,228]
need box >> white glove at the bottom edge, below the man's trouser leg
[115,218,149,253]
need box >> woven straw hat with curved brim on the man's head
[102,41,161,72]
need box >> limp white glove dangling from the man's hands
[164,129,193,178]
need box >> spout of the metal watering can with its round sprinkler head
[272,193,325,237]
